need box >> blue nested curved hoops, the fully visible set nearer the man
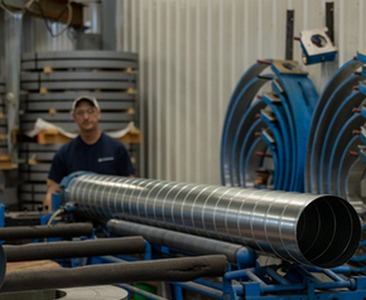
[221,60,318,192]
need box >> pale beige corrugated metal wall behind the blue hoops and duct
[117,0,366,183]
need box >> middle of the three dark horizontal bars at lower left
[3,236,145,262]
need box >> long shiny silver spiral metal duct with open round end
[62,174,361,267]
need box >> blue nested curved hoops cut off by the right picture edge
[305,52,366,213]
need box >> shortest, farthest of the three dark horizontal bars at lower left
[0,223,93,241]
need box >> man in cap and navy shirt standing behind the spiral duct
[43,96,134,211]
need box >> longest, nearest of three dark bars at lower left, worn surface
[0,255,227,293]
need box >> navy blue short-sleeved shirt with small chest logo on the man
[48,133,135,183]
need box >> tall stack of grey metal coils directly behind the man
[19,51,138,209]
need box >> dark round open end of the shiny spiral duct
[297,196,361,268]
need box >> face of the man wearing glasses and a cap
[72,101,100,131]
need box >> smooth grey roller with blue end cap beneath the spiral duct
[107,219,256,265]
